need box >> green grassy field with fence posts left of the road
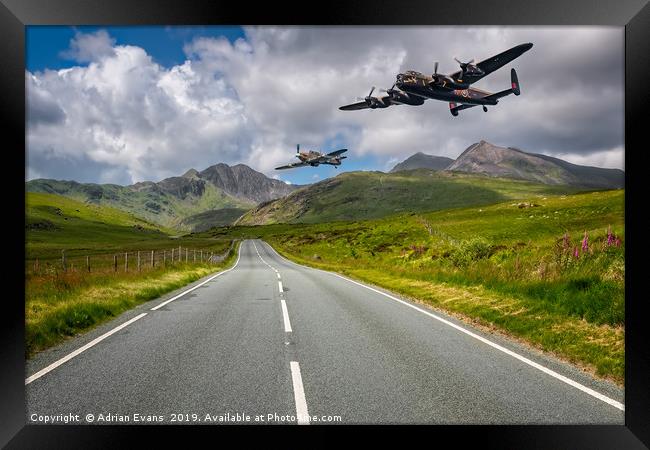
[25,193,236,356]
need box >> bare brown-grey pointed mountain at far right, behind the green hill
[447,141,625,189]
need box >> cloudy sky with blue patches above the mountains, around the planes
[26,26,624,184]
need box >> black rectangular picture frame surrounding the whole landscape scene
[0,0,650,449]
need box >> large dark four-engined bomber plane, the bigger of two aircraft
[339,43,533,116]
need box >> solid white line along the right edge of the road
[265,242,625,411]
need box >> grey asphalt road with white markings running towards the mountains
[26,240,624,424]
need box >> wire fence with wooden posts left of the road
[26,240,235,276]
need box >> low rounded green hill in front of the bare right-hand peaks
[235,169,579,225]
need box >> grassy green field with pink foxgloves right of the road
[204,190,625,384]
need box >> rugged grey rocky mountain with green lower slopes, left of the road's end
[25,164,297,231]
